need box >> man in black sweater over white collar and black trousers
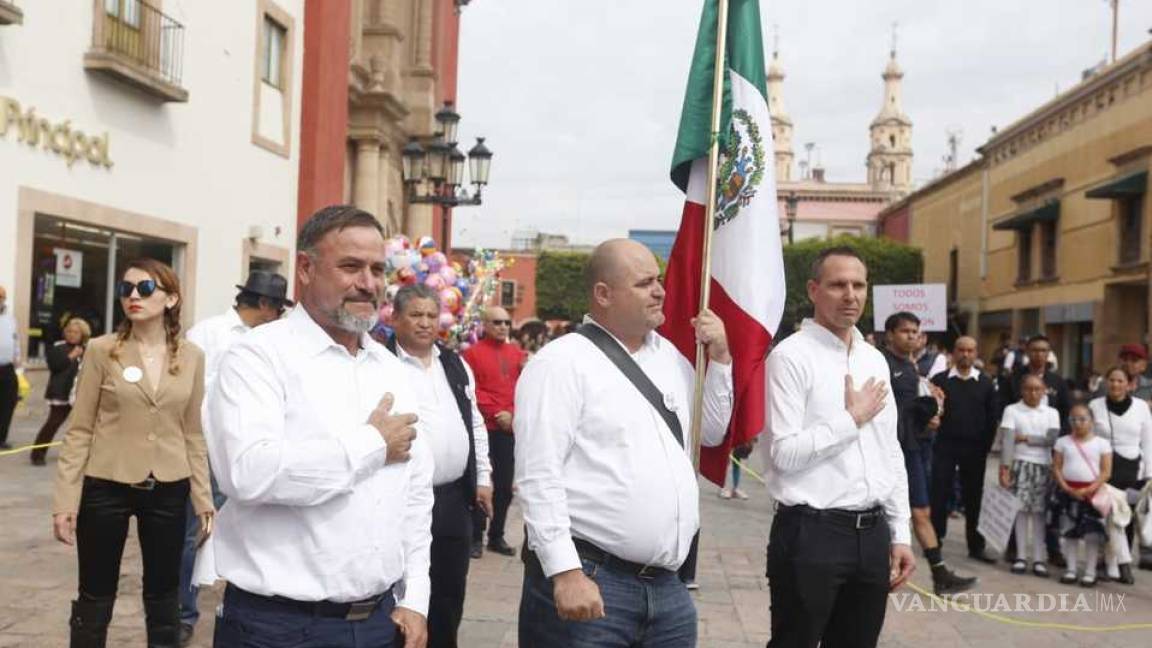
[929,336,996,564]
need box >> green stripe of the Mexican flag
[672,0,768,191]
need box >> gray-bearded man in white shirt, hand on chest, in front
[197,205,433,648]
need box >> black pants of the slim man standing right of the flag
[768,507,890,648]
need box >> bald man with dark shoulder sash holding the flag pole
[514,239,733,648]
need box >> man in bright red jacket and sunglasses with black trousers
[462,306,525,558]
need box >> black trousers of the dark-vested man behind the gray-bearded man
[427,481,472,648]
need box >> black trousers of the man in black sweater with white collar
[931,443,987,553]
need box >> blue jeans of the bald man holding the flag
[520,558,696,648]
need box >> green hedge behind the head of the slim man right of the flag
[780,236,924,332]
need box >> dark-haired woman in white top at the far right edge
[1089,367,1152,585]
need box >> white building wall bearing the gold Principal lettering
[0,0,304,357]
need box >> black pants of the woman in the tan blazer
[76,477,189,604]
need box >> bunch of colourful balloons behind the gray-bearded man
[379,235,503,346]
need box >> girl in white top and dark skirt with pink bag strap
[1052,405,1112,587]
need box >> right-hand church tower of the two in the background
[867,46,912,193]
